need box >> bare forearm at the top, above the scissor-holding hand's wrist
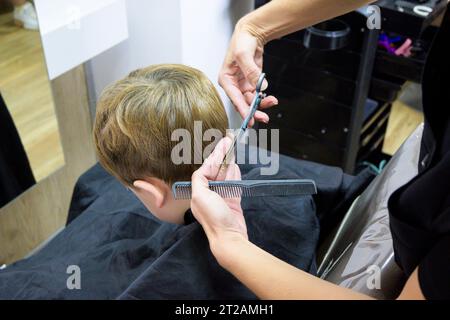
[241,0,374,44]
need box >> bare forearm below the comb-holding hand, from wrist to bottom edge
[212,239,371,300]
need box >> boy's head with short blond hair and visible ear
[94,64,228,223]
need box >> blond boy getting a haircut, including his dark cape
[0,65,330,299]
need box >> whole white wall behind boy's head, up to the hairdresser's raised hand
[84,0,253,127]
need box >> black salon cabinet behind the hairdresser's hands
[257,0,442,173]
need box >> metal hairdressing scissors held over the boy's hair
[215,73,266,180]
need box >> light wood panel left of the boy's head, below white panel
[0,66,96,265]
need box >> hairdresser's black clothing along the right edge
[389,8,450,299]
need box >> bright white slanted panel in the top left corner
[34,0,128,79]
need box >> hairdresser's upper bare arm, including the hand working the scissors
[219,0,373,122]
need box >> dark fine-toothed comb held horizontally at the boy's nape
[172,179,317,200]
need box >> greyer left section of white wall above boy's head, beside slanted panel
[86,0,182,99]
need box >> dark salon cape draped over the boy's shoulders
[0,156,373,299]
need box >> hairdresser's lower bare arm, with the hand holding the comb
[191,138,423,299]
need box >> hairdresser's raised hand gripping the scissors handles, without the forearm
[219,20,278,125]
